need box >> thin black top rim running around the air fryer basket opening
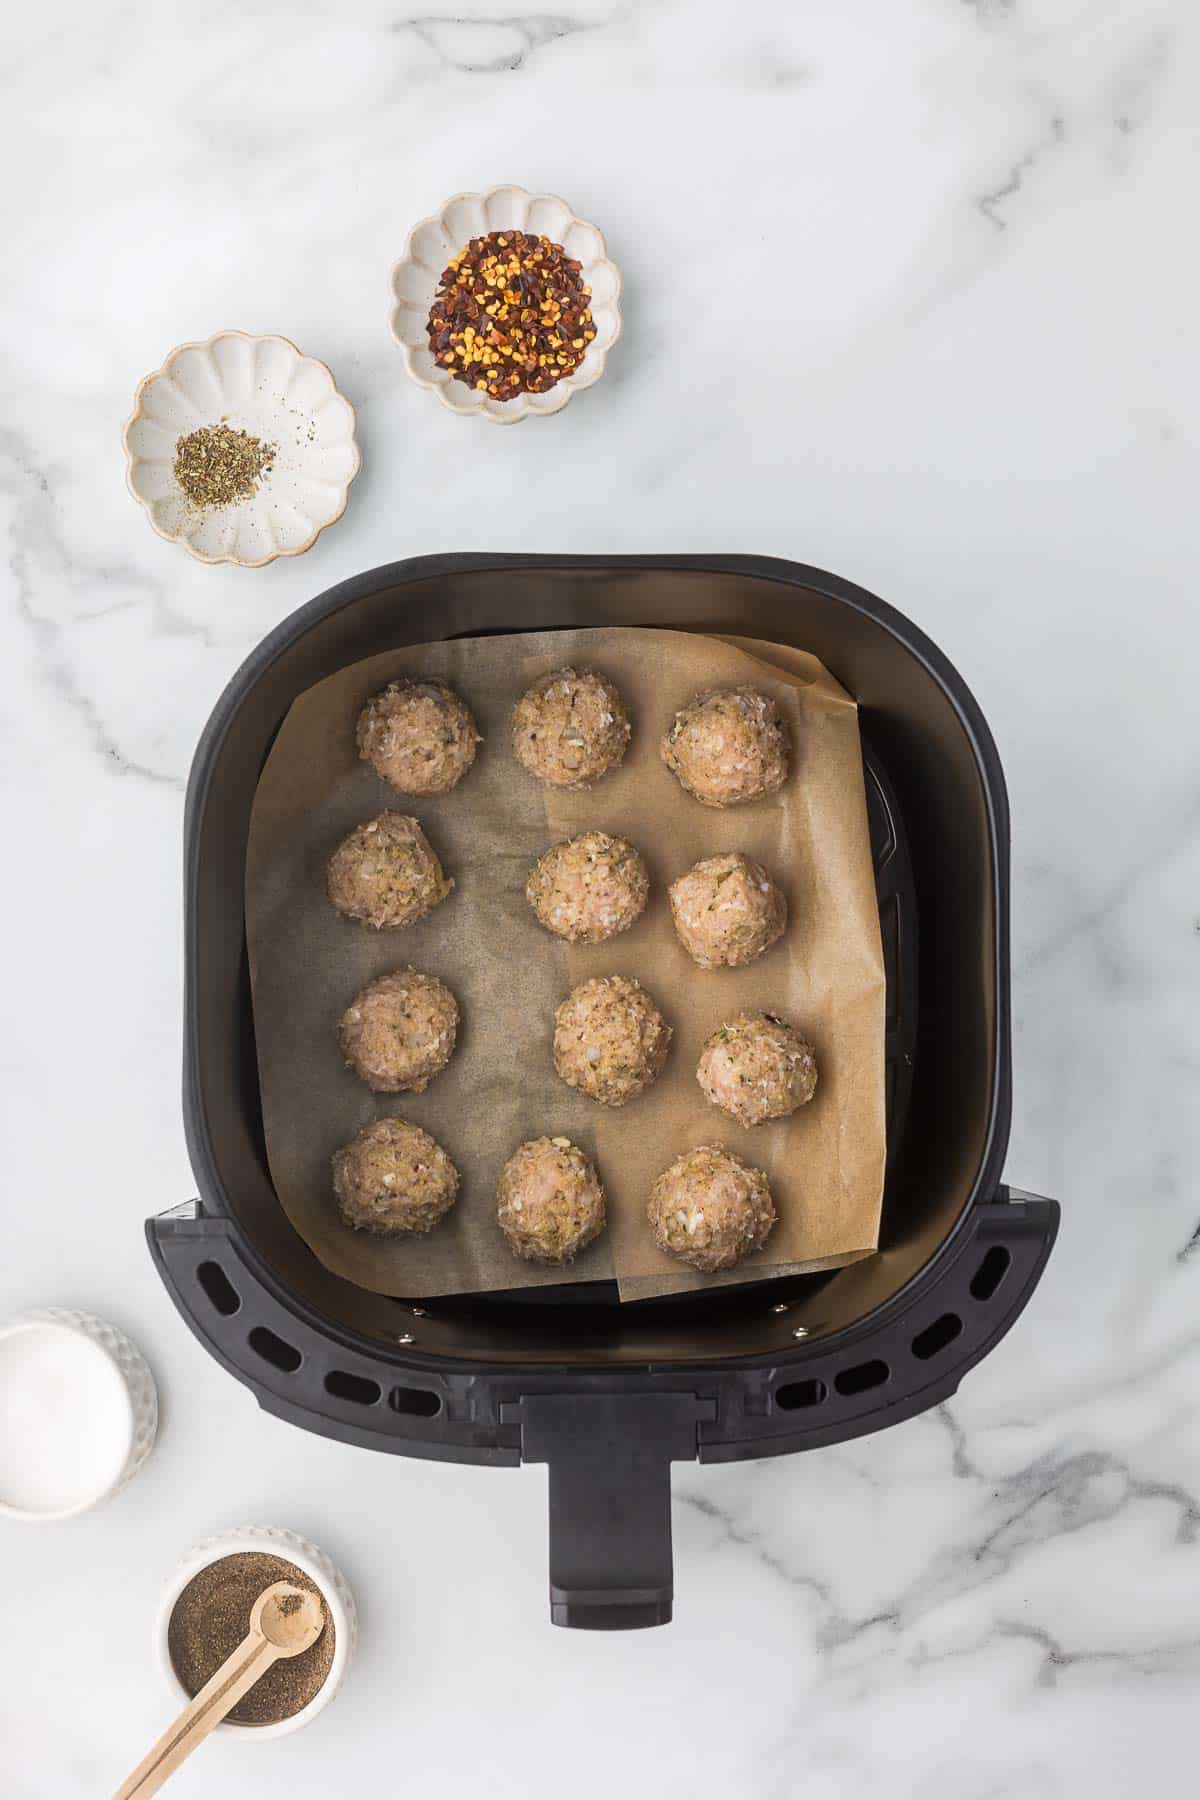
[184,553,1011,1370]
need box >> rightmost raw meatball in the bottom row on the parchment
[646,1143,775,1274]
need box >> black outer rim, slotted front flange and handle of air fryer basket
[159,554,1058,1629]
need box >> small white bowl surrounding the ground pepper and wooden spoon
[155,1525,358,1741]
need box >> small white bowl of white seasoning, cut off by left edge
[0,1309,158,1523]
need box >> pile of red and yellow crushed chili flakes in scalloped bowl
[428,230,596,400]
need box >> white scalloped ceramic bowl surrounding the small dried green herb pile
[124,331,360,569]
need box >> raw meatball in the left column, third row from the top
[338,968,459,1094]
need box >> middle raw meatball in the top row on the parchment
[513,670,630,787]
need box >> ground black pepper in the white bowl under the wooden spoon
[167,1550,336,1724]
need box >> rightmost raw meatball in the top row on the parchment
[658,688,790,806]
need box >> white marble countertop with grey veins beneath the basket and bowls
[0,0,1200,1800]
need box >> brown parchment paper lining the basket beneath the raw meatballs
[246,628,885,1300]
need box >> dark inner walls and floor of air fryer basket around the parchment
[185,556,1009,1363]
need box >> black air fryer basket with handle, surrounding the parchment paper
[148,556,1058,1629]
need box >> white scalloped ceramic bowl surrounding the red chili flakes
[389,187,621,425]
